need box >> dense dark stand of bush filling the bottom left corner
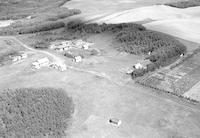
[0,88,73,138]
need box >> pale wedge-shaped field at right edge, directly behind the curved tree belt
[144,18,200,43]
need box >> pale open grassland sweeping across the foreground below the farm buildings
[0,36,200,138]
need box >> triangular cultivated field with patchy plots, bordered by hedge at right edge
[138,48,200,101]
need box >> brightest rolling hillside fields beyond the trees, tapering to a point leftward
[93,5,200,43]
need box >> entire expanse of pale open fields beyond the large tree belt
[65,0,200,43]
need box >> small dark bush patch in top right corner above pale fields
[165,0,200,8]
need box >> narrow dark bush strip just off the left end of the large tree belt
[18,21,65,34]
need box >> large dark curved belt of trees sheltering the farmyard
[67,21,186,76]
